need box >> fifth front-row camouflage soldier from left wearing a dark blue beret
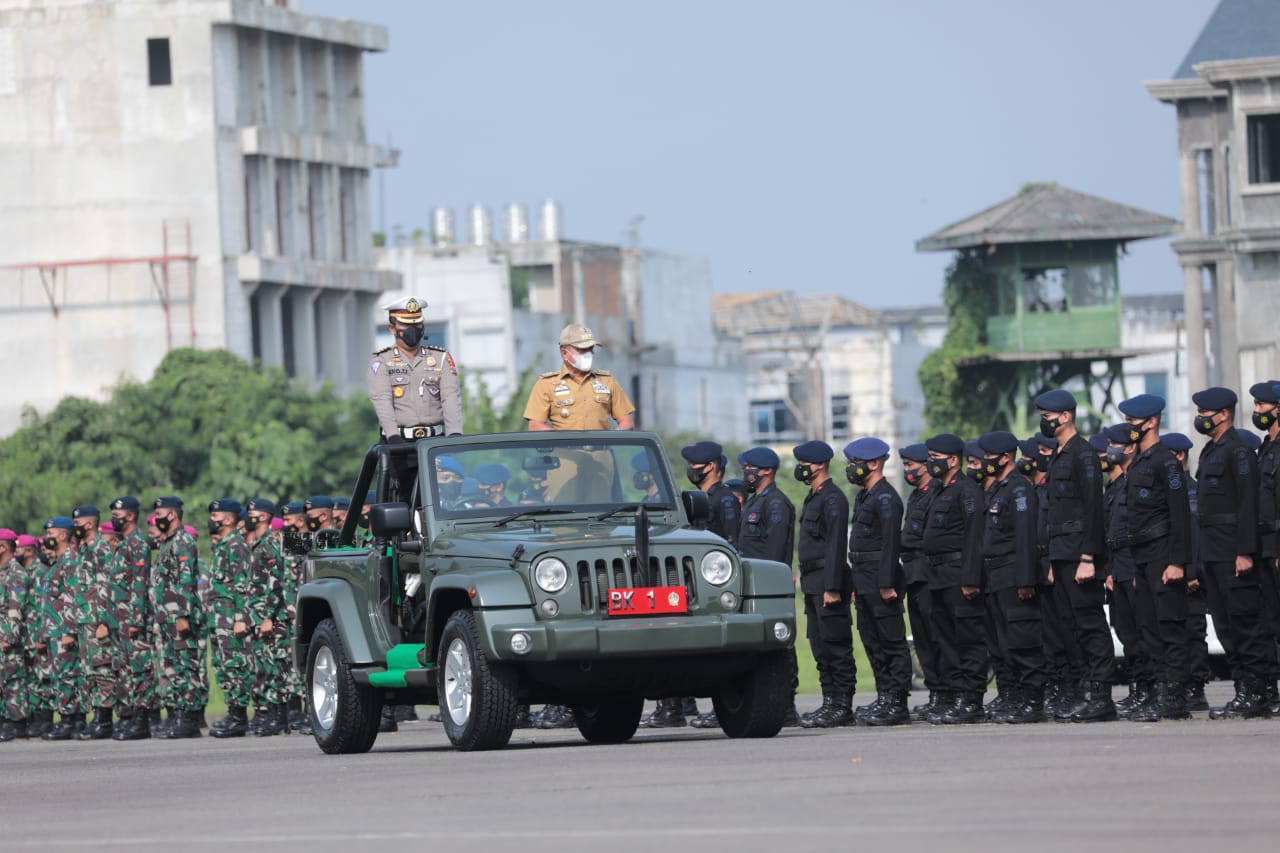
[206,498,253,738]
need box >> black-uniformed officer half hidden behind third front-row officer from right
[1091,424,1156,716]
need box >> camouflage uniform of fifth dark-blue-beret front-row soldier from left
[207,532,253,708]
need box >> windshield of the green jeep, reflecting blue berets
[424,432,677,521]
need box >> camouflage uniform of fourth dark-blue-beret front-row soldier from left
[151,528,206,711]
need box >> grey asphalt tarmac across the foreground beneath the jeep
[0,683,1280,853]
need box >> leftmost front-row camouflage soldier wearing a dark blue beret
[41,515,84,740]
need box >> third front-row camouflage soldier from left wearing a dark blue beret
[110,494,156,740]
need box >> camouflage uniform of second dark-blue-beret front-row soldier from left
[76,537,124,708]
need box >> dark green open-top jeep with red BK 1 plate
[293,432,796,753]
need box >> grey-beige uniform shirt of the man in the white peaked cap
[365,346,462,438]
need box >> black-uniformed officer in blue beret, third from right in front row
[1120,394,1196,722]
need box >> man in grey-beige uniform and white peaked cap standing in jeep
[365,296,462,444]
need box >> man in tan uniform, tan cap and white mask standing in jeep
[525,323,636,430]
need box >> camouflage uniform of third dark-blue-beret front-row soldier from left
[111,528,156,708]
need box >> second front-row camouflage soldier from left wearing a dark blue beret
[72,503,123,740]
